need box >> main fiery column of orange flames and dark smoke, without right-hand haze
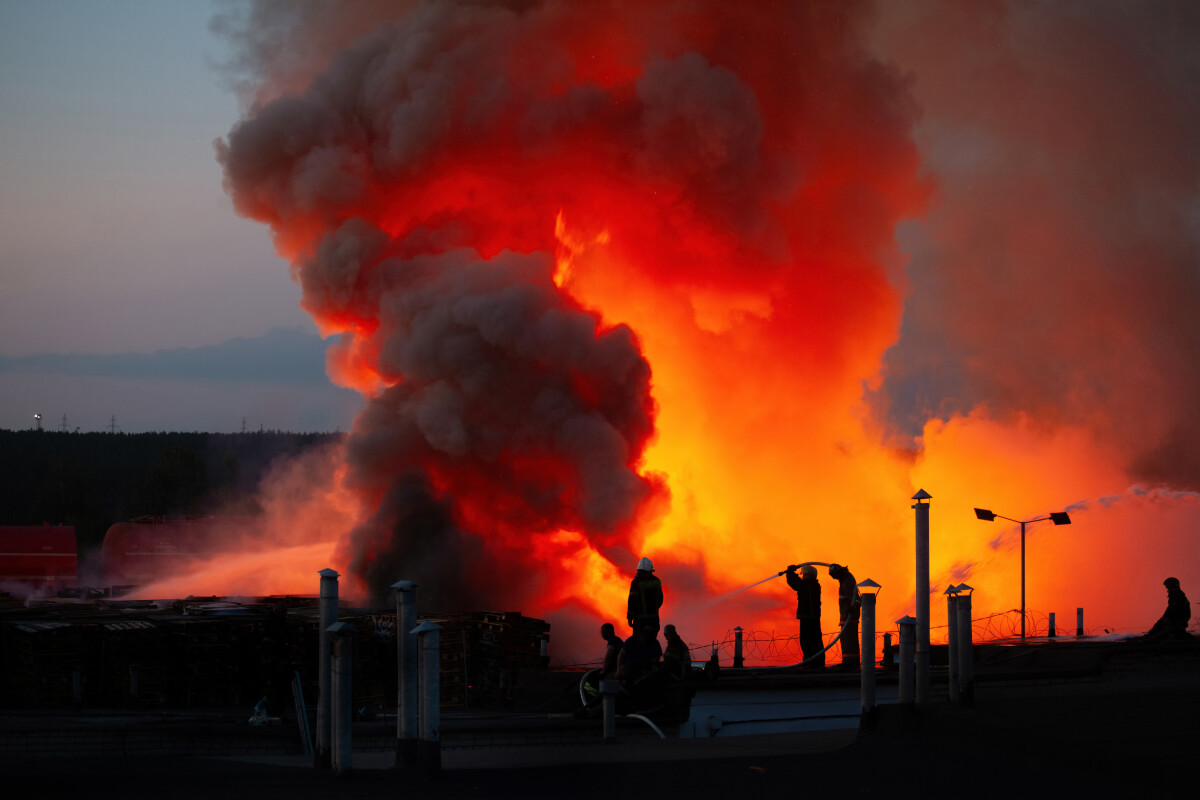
[211,2,1200,662]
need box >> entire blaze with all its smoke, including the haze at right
[150,0,1200,655]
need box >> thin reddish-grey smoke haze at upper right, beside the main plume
[872,1,1200,488]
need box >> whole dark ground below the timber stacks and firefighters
[0,643,1200,800]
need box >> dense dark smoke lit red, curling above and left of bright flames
[218,2,914,618]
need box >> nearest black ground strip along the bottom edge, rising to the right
[0,684,1200,800]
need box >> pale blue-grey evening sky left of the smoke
[0,0,356,433]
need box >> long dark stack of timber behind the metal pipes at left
[0,597,550,717]
